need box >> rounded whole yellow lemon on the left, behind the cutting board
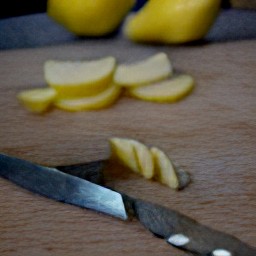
[47,0,135,36]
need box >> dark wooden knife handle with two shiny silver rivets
[133,199,256,256]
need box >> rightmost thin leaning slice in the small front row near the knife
[150,147,179,189]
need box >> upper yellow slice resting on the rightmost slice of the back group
[114,53,172,87]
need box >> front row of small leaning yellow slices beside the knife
[109,137,190,190]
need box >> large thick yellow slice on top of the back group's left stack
[44,57,116,98]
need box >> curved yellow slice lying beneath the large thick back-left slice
[54,84,121,111]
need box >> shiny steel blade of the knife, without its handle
[0,154,128,220]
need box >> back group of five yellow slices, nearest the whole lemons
[18,53,194,113]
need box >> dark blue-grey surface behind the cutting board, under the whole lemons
[0,9,256,50]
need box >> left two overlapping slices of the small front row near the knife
[110,138,154,179]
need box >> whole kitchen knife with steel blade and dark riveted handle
[0,154,256,256]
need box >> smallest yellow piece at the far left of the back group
[17,88,57,113]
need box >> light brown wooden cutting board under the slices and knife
[0,38,256,256]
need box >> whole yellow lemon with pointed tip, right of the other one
[124,0,221,44]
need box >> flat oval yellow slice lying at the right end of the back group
[128,75,194,102]
